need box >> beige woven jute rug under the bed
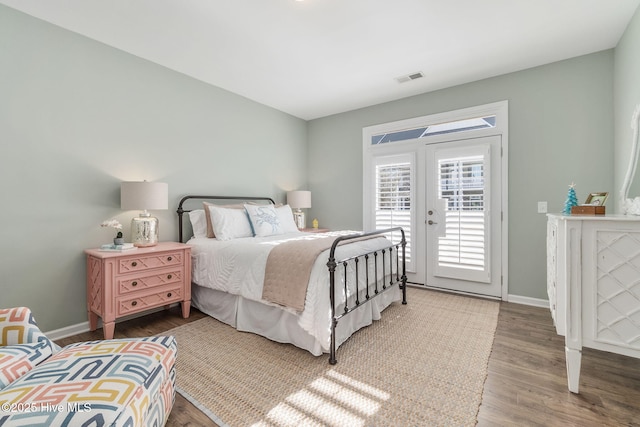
[163,288,499,427]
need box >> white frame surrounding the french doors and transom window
[362,100,509,301]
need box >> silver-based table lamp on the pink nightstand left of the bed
[120,181,169,247]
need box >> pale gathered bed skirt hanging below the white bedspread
[191,283,402,356]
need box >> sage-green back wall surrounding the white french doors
[308,50,614,299]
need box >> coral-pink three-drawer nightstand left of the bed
[85,242,191,339]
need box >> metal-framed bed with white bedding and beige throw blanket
[177,195,407,364]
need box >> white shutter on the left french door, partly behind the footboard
[375,156,414,267]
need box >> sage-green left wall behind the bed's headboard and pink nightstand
[0,6,307,331]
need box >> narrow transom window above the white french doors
[371,115,496,145]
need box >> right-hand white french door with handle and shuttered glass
[425,136,502,297]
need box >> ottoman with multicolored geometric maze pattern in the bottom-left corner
[0,336,177,427]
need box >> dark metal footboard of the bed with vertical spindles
[327,227,407,365]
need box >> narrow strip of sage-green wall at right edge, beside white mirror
[614,3,640,207]
